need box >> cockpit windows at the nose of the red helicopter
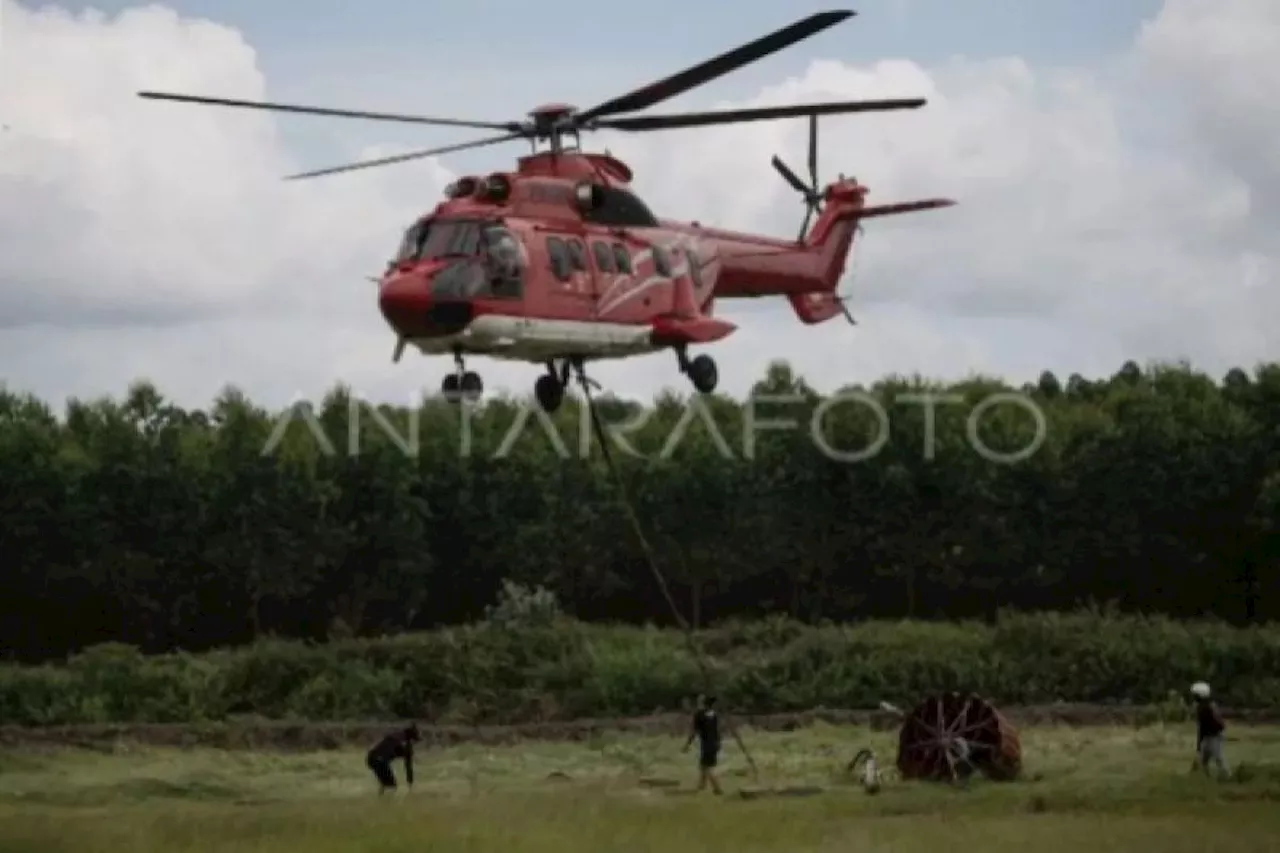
[394,219,525,298]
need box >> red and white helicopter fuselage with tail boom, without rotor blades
[379,152,865,362]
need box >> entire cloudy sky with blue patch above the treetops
[0,0,1280,405]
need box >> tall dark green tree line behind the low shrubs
[0,362,1280,661]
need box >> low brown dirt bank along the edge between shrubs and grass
[0,703,1280,752]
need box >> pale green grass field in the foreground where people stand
[0,725,1280,853]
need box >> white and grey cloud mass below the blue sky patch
[0,0,1280,402]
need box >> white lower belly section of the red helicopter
[411,314,663,364]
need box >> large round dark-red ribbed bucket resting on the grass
[897,692,1023,783]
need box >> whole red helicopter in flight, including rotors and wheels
[138,10,955,411]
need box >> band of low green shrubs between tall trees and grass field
[0,612,1280,725]
